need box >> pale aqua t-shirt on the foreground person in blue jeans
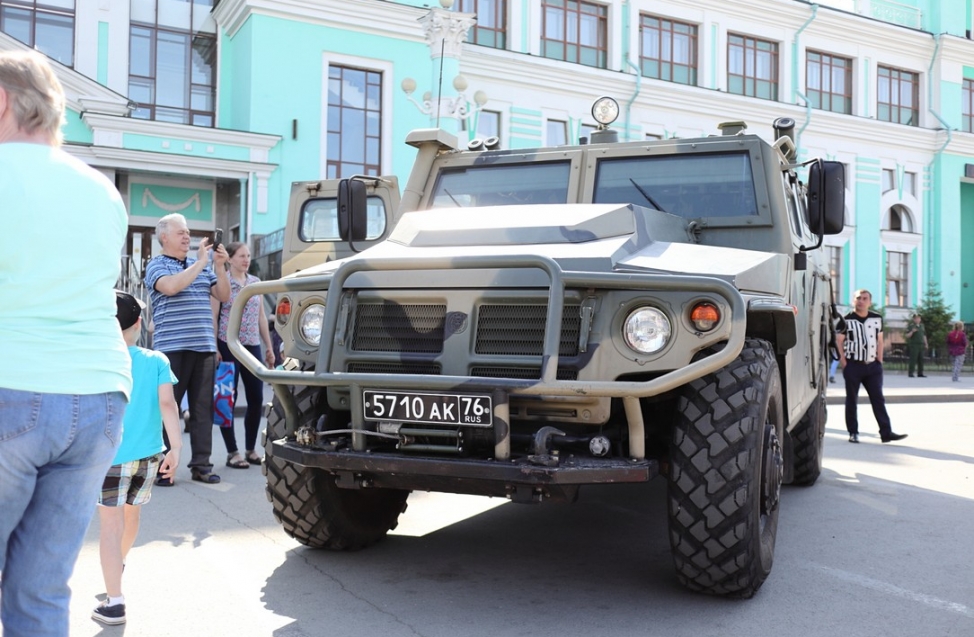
[0,142,132,396]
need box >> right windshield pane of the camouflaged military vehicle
[593,152,758,219]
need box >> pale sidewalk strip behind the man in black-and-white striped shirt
[825,370,974,405]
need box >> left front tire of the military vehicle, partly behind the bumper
[264,387,409,551]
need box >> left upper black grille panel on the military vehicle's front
[352,303,446,354]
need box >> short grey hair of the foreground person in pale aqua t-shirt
[0,51,65,144]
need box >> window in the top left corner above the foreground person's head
[0,0,75,66]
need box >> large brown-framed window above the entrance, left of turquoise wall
[128,0,216,127]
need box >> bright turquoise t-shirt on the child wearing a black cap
[112,345,176,464]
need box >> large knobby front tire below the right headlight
[668,339,784,597]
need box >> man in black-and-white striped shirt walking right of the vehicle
[835,290,906,442]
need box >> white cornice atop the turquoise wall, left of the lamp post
[213,0,429,42]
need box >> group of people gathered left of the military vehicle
[0,51,276,637]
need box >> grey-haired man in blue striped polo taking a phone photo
[145,213,230,486]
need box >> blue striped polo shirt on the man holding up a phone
[145,254,216,352]
